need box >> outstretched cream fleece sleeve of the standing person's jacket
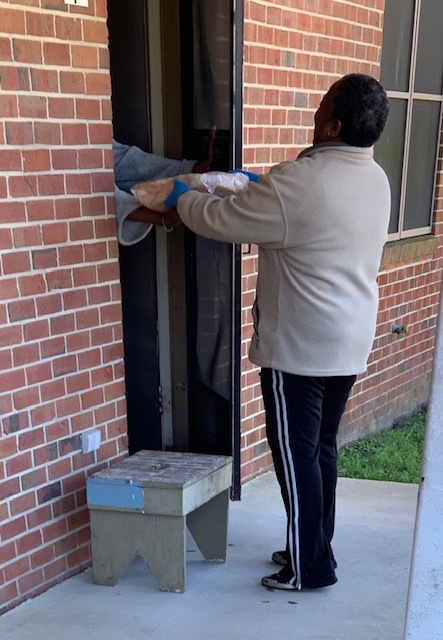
[177,175,287,249]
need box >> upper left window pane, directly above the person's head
[381,0,414,91]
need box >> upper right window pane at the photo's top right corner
[415,0,443,95]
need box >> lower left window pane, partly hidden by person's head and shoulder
[375,98,408,233]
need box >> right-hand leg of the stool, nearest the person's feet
[186,489,229,562]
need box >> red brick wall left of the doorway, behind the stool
[0,0,126,613]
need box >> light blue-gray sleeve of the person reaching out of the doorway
[112,140,196,246]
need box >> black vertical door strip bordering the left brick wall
[108,0,162,453]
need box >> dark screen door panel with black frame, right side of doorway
[181,0,242,495]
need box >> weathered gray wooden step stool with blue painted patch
[86,451,232,592]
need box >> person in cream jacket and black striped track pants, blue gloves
[163,74,390,590]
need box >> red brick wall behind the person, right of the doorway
[242,0,443,480]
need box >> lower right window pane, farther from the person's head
[404,100,441,230]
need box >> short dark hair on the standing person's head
[332,73,389,147]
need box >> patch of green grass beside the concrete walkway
[338,411,426,483]
